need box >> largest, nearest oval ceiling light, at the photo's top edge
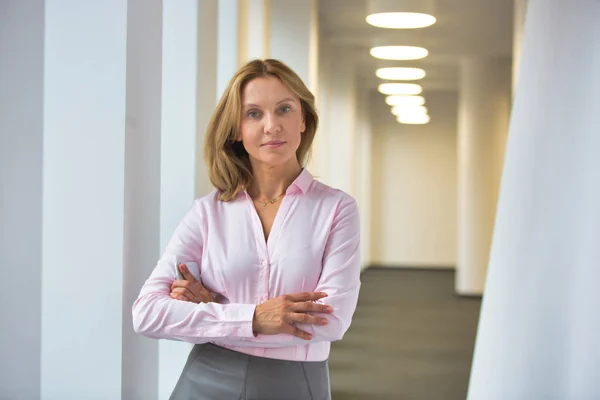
[367,0,436,29]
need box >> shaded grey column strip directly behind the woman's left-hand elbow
[122,0,164,400]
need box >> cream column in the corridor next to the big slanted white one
[456,58,510,295]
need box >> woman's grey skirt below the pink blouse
[170,343,331,400]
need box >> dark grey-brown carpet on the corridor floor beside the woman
[329,268,481,400]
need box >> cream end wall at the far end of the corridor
[371,92,457,267]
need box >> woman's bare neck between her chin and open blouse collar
[248,160,302,201]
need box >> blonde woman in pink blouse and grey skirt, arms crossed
[133,60,360,400]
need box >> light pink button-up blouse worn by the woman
[133,170,360,361]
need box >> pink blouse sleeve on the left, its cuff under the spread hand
[132,200,256,343]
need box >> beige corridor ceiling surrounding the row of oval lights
[318,0,513,91]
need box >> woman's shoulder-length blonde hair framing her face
[204,59,319,201]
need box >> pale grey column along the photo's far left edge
[0,0,44,399]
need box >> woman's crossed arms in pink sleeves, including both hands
[133,200,360,347]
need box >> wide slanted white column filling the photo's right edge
[468,0,600,400]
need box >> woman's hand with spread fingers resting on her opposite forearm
[252,292,333,340]
